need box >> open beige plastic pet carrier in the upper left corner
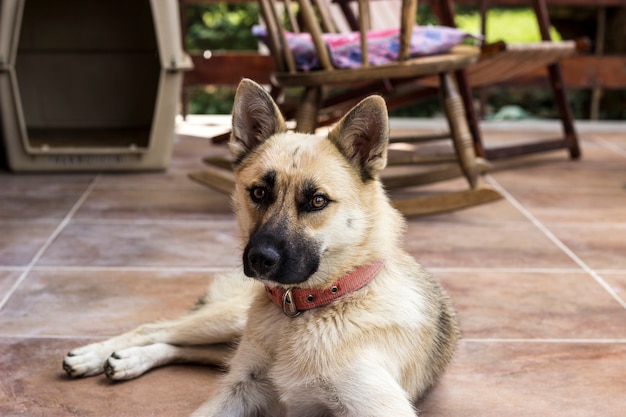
[0,0,191,172]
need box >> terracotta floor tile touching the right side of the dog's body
[434,271,626,340]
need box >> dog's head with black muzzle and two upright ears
[230,80,389,286]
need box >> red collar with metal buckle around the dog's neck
[265,259,385,317]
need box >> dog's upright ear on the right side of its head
[328,96,389,181]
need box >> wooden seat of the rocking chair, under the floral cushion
[272,45,480,86]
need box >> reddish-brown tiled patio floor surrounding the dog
[0,118,626,417]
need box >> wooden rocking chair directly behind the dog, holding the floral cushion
[191,0,501,216]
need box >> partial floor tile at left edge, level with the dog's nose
[0,219,59,266]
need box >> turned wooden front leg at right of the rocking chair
[439,73,478,188]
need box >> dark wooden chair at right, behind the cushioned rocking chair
[428,0,589,160]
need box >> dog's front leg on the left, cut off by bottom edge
[192,337,284,417]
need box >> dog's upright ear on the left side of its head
[229,78,287,165]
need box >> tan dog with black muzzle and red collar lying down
[63,79,459,417]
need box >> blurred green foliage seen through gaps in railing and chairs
[185,3,626,120]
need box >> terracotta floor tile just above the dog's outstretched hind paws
[0,269,212,338]
